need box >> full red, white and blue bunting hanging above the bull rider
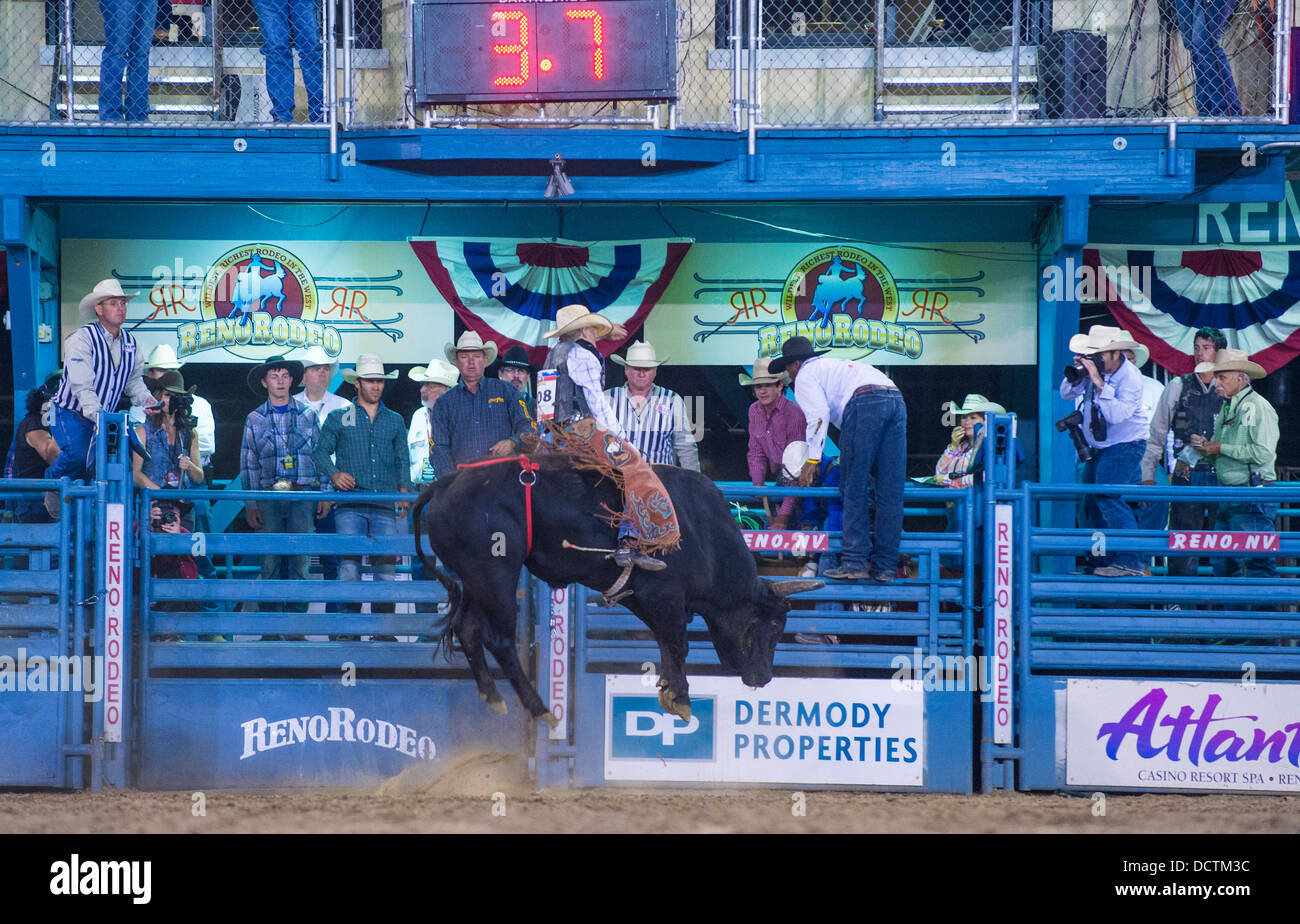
[411,238,690,364]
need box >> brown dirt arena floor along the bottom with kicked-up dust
[0,754,1300,834]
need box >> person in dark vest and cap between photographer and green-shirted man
[1141,327,1227,577]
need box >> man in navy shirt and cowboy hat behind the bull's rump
[429,330,537,478]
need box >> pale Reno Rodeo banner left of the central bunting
[61,240,452,365]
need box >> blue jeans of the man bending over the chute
[840,391,907,574]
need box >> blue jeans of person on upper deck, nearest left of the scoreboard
[252,0,325,122]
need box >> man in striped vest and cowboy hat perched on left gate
[46,279,153,520]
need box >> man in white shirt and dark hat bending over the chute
[767,337,907,584]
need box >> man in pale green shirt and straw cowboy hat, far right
[1191,350,1281,578]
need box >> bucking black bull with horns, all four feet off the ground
[415,455,822,724]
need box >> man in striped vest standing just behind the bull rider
[605,342,699,472]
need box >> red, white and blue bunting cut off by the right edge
[1084,247,1300,373]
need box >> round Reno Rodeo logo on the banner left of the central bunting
[176,244,343,361]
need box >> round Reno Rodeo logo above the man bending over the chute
[758,247,923,359]
